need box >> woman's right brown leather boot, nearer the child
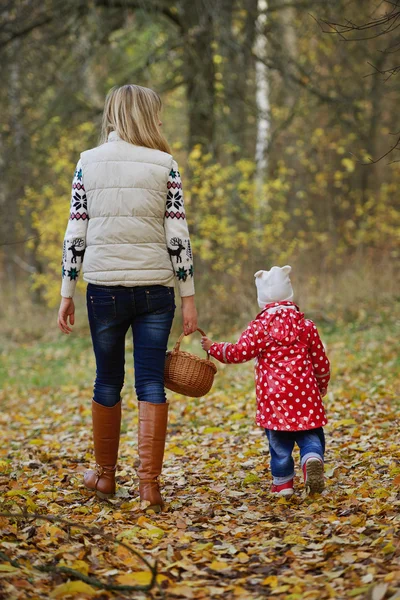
[138,402,168,512]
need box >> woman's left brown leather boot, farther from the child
[83,400,121,498]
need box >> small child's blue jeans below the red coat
[265,427,325,485]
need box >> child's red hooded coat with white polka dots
[210,301,330,431]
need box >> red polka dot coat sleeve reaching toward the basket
[210,321,268,363]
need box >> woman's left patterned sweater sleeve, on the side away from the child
[61,160,89,298]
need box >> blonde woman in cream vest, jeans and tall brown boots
[58,85,197,512]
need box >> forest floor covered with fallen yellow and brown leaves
[0,315,400,600]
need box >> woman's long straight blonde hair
[100,84,171,154]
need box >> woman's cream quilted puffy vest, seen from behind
[81,132,174,286]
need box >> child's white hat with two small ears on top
[254,265,293,308]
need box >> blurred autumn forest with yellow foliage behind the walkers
[0,0,400,341]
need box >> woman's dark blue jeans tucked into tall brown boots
[86,283,175,406]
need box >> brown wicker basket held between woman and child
[164,329,217,398]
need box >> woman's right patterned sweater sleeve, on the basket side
[164,161,194,297]
